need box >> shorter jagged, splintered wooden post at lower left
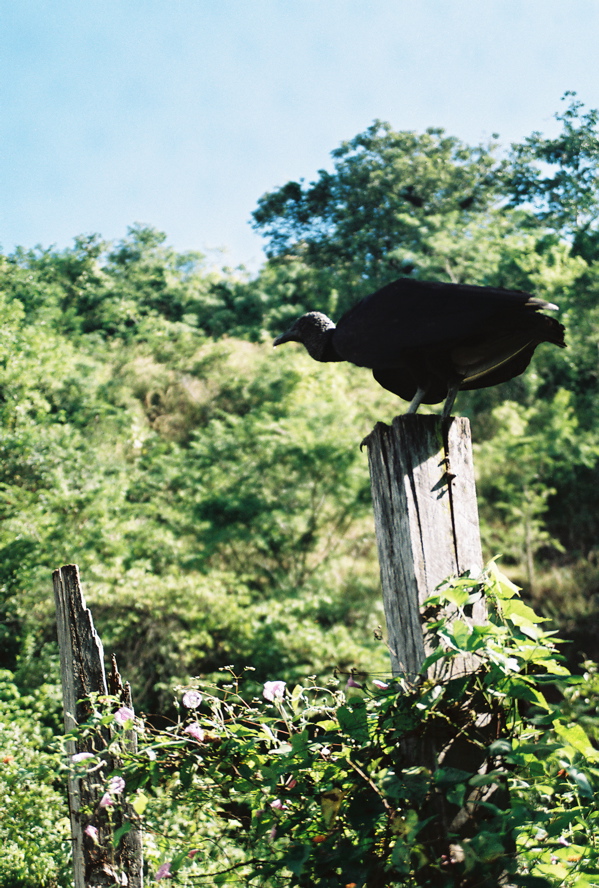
[52,564,143,888]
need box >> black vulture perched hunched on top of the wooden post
[274,278,565,418]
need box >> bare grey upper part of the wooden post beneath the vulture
[364,414,485,678]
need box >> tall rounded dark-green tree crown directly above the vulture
[254,121,501,310]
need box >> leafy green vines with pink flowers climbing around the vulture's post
[70,566,599,888]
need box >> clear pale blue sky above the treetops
[0,0,599,268]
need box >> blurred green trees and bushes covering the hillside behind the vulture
[0,96,599,885]
